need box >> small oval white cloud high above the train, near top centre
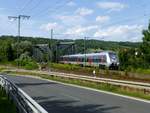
[75,7,93,16]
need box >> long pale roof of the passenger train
[62,51,115,57]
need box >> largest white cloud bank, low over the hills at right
[94,25,143,41]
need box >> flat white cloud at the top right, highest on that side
[97,2,126,11]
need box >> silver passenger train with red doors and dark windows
[59,51,120,69]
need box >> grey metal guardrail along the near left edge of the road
[0,75,48,113]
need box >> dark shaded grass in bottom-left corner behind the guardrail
[0,88,16,113]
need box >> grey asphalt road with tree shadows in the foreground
[6,76,150,113]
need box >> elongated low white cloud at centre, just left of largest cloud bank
[65,25,98,35]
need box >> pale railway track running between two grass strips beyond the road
[1,69,150,92]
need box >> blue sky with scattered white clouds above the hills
[0,0,150,42]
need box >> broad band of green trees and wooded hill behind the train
[0,22,150,70]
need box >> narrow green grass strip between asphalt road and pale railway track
[4,71,150,100]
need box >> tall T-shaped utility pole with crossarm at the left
[8,15,30,67]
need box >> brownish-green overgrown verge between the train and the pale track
[48,63,150,82]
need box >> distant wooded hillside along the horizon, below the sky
[0,36,140,53]
